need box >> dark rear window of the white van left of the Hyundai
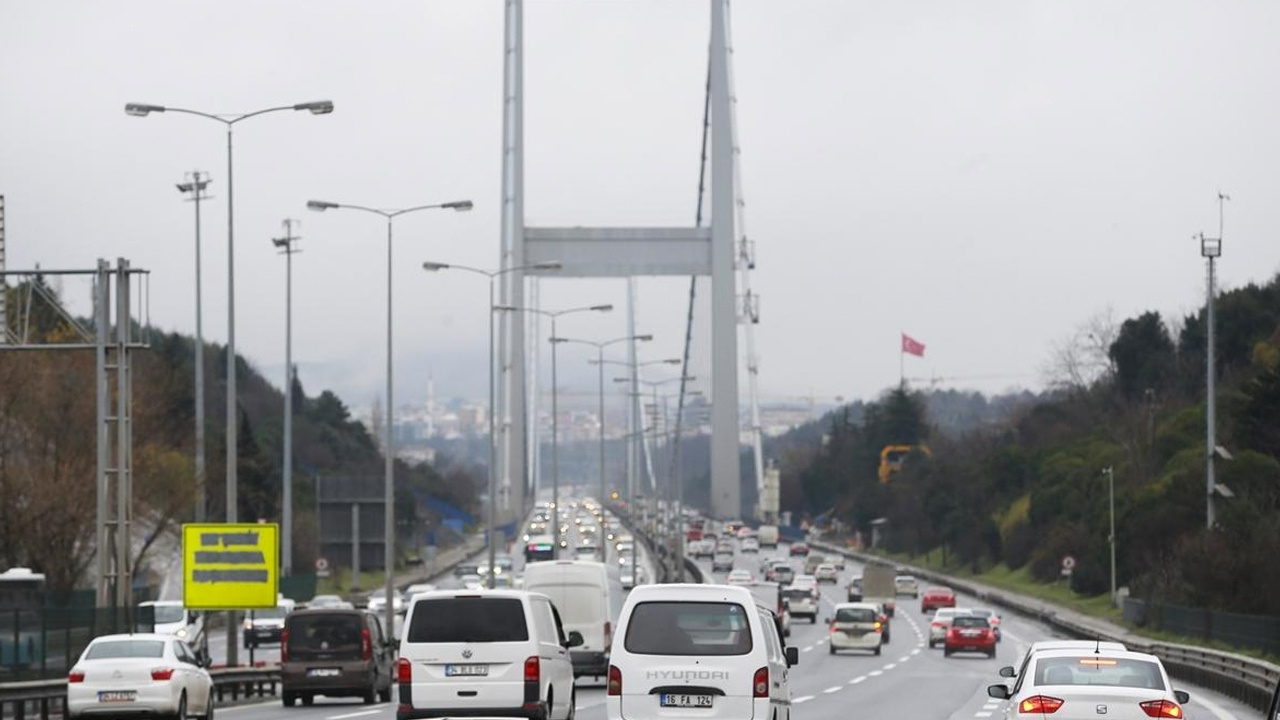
[408,597,529,643]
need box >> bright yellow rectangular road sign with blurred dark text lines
[182,523,280,610]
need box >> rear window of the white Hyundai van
[626,602,751,656]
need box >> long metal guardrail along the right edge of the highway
[809,542,1280,711]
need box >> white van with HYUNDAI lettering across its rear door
[604,584,799,720]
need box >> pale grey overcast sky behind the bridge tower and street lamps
[0,0,1280,406]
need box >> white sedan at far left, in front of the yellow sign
[67,633,214,720]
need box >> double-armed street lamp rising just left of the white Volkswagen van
[307,200,472,634]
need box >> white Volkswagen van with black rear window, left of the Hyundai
[396,591,582,720]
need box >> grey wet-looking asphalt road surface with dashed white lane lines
[194,525,1256,720]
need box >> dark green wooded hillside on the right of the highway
[780,274,1280,614]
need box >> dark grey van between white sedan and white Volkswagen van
[280,609,396,707]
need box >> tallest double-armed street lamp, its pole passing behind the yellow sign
[124,100,333,666]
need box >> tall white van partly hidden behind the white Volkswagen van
[525,560,613,678]
